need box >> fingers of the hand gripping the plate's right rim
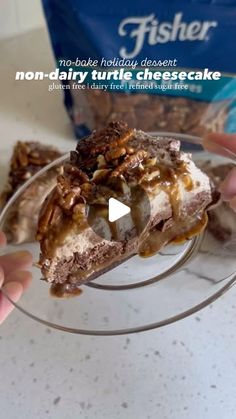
[203,134,236,211]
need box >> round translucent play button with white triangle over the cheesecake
[86,182,151,243]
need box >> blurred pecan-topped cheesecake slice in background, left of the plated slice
[0,141,62,244]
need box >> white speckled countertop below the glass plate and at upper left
[0,30,236,419]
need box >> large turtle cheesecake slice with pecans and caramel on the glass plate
[37,122,217,295]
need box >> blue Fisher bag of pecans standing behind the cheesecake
[43,0,236,137]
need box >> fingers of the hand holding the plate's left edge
[0,231,32,324]
